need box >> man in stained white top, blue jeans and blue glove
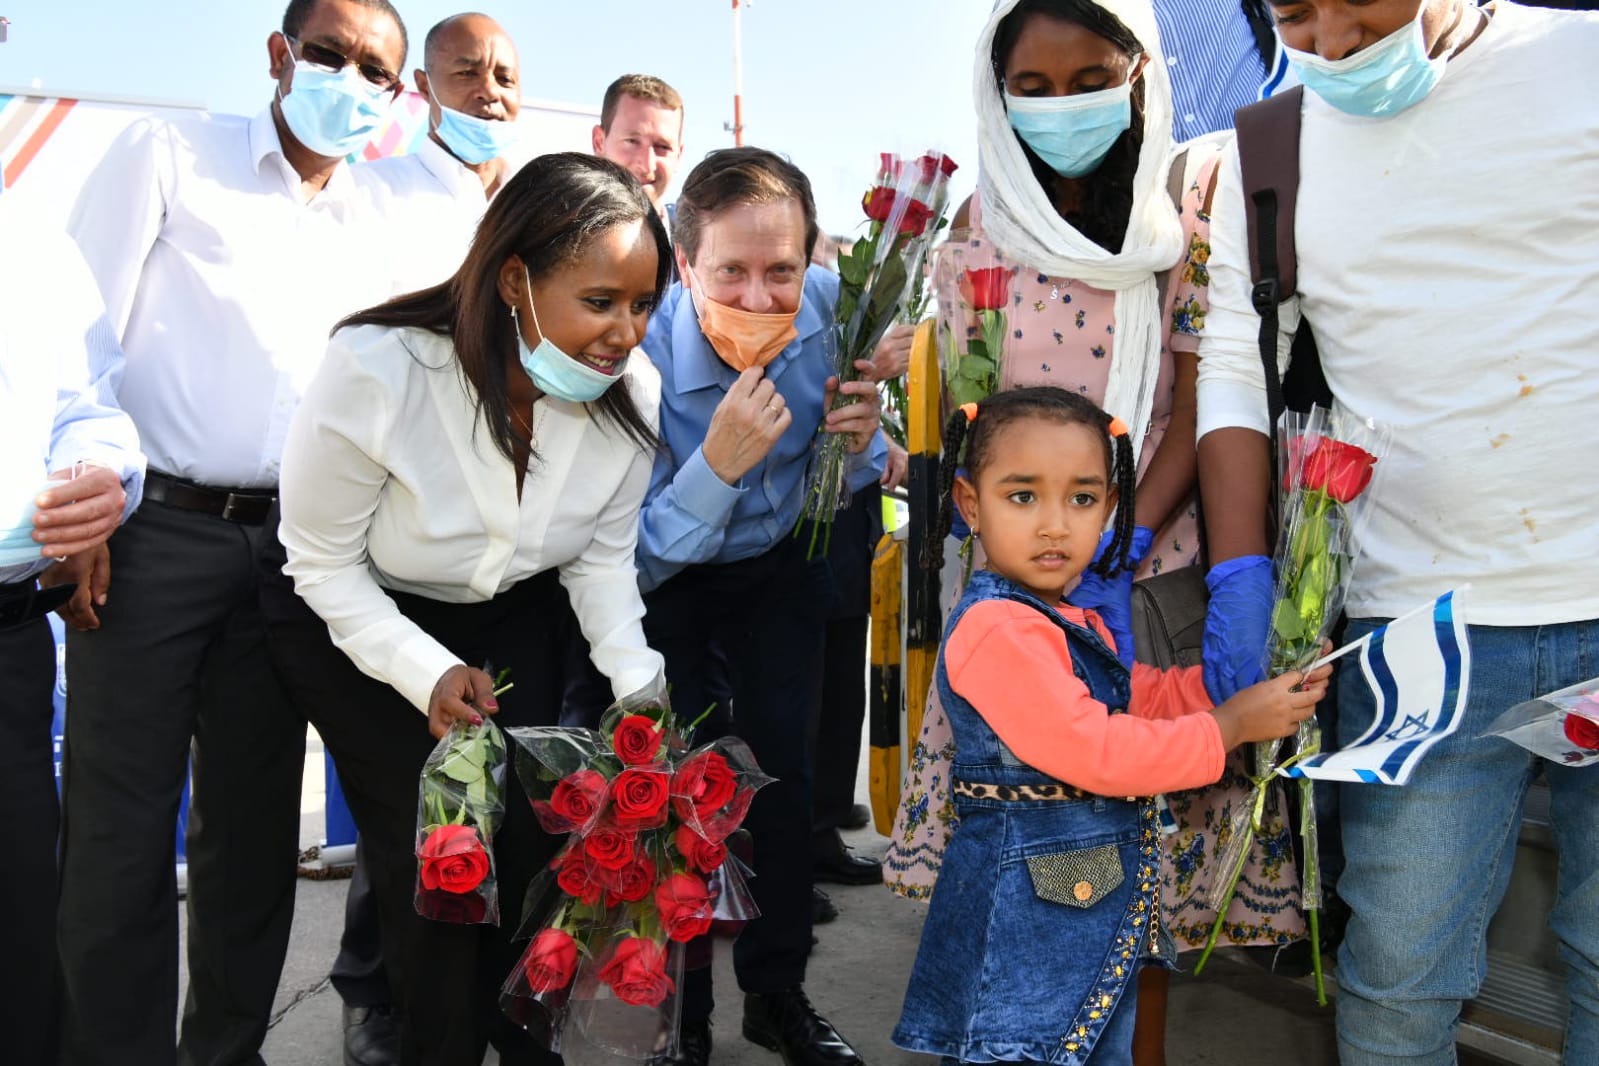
[1198,0,1599,1066]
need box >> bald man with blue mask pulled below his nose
[355,13,521,292]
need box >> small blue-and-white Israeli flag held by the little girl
[1284,588,1471,785]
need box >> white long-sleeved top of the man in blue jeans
[1198,3,1599,625]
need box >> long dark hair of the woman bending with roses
[334,152,672,460]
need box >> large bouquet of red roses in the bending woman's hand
[500,692,771,1058]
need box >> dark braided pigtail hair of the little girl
[921,385,1137,577]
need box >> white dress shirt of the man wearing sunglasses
[69,110,389,487]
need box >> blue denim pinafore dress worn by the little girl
[894,571,1166,1066]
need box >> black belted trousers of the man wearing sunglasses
[58,502,305,1066]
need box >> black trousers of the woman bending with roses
[262,556,569,1066]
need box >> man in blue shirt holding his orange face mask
[638,149,886,1066]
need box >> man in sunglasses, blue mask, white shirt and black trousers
[58,0,406,1064]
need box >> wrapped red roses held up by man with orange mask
[800,152,956,555]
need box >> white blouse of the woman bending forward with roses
[278,326,662,711]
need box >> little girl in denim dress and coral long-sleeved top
[894,387,1329,1066]
